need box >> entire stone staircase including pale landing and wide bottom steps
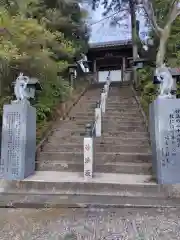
[0,82,179,207]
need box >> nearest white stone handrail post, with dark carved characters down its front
[84,124,94,180]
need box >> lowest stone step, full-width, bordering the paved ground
[0,195,180,209]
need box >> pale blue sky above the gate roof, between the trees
[82,1,148,43]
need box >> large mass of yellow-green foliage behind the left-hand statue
[0,0,88,133]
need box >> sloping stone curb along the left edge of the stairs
[36,84,89,156]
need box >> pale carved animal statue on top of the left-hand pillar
[14,73,30,102]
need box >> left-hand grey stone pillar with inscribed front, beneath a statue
[0,100,36,180]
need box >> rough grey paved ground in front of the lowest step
[0,208,180,240]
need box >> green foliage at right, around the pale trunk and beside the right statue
[135,0,180,115]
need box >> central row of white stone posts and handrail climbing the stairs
[84,71,111,180]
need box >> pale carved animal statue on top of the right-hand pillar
[156,64,174,98]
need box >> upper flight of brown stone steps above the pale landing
[37,83,151,174]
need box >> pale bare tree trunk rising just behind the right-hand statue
[156,25,171,67]
